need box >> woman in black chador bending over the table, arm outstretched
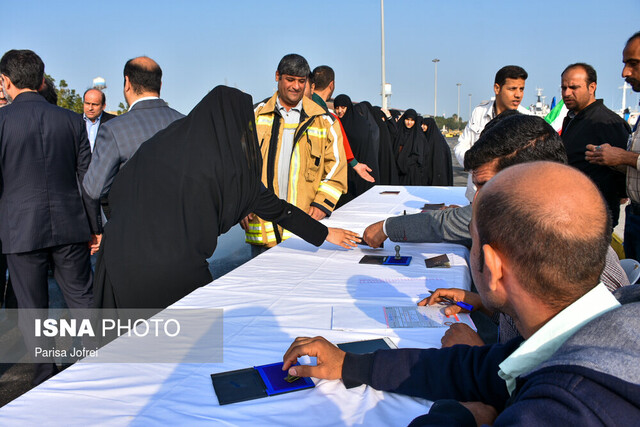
[94,86,356,309]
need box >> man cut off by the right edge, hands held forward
[586,31,640,260]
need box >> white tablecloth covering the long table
[0,186,471,426]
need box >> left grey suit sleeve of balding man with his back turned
[83,123,120,200]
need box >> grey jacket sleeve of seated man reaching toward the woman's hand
[385,205,473,247]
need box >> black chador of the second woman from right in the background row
[393,109,429,185]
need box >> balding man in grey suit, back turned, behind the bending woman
[83,56,184,222]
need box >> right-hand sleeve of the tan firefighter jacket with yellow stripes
[308,116,347,216]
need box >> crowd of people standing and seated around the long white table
[0,29,640,425]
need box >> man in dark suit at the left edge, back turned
[0,50,99,384]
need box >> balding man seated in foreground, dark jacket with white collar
[283,162,640,425]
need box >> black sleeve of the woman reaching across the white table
[254,185,329,246]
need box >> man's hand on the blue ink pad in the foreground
[282,337,346,380]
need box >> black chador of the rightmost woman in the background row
[421,117,453,186]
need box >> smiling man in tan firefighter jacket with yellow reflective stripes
[241,54,347,254]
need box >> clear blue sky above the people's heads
[6,0,640,120]
